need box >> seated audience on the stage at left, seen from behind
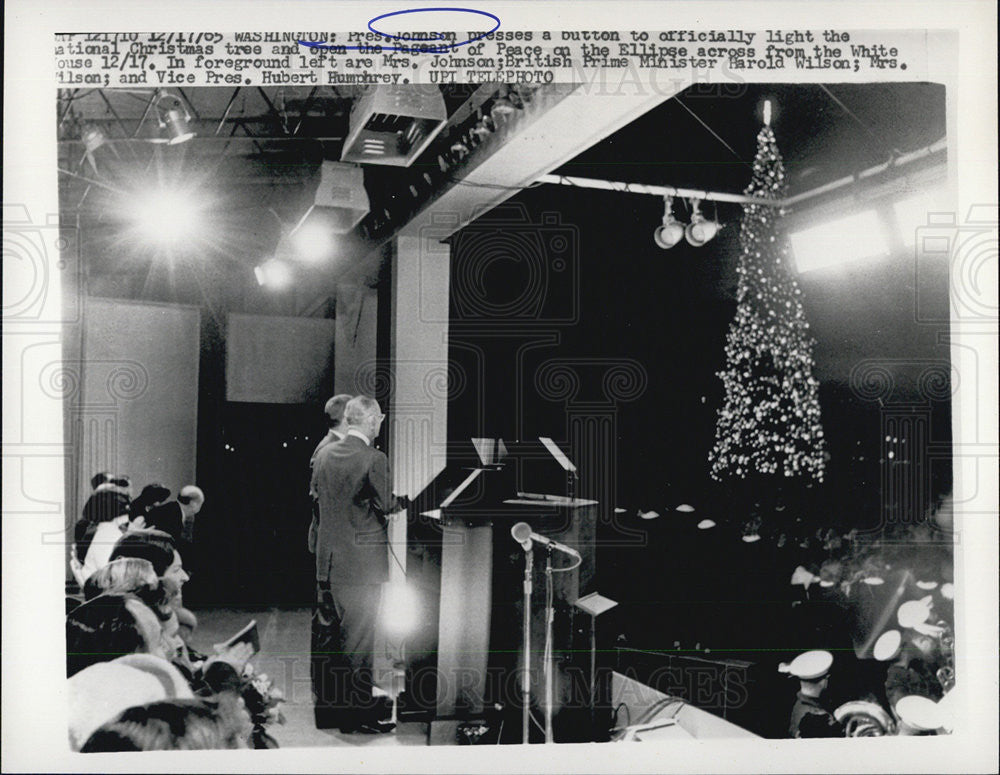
[66,474,276,752]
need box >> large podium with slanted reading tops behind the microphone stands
[407,441,599,740]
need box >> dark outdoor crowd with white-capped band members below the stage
[624,496,956,737]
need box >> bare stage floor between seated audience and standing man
[194,608,430,748]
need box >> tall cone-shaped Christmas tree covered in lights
[708,118,825,480]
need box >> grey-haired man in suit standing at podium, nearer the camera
[311,396,407,733]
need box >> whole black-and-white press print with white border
[3,3,998,772]
